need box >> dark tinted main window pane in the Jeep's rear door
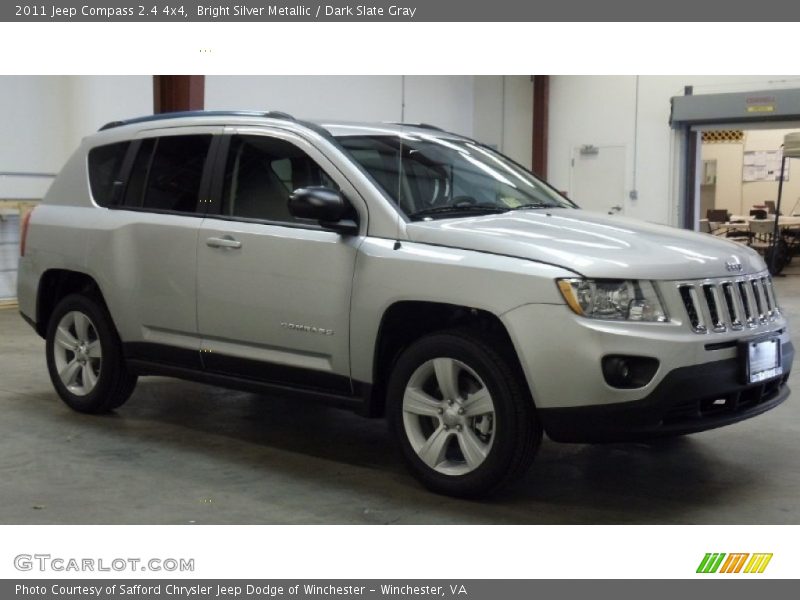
[137,135,211,212]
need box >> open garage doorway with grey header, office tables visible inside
[670,89,800,274]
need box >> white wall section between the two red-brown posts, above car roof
[206,75,533,165]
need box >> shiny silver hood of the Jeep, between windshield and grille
[407,208,766,280]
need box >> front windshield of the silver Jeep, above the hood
[337,133,575,220]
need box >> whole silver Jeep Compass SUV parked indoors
[18,113,794,495]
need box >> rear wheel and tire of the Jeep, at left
[46,294,136,414]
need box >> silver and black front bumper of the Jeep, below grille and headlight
[501,298,794,441]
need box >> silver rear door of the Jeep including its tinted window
[98,127,223,368]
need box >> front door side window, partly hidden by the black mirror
[222,135,338,223]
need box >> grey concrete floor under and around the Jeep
[0,275,800,524]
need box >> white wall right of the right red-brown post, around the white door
[548,75,800,225]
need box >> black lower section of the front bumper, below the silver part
[539,342,794,442]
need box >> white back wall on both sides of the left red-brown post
[0,75,533,198]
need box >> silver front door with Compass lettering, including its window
[197,129,366,394]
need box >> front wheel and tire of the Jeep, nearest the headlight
[387,329,542,497]
